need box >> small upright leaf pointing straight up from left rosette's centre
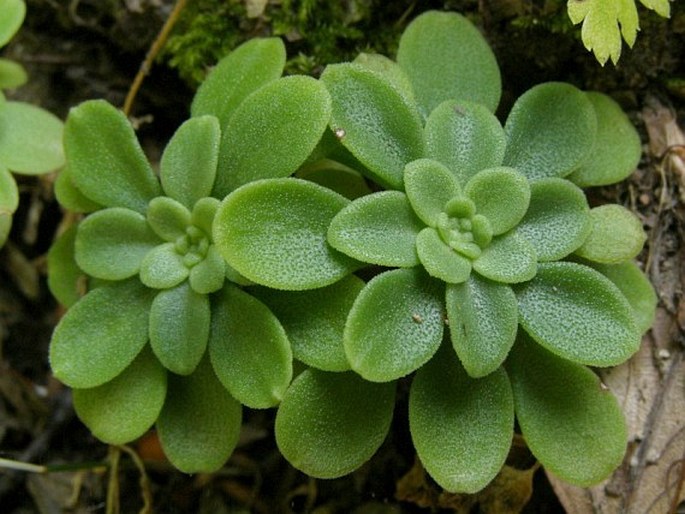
[159,116,221,209]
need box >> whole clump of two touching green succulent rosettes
[49,12,655,492]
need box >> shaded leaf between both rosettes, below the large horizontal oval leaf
[252,275,364,371]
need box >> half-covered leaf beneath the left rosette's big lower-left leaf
[73,349,167,444]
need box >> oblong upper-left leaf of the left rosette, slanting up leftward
[64,100,162,214]
